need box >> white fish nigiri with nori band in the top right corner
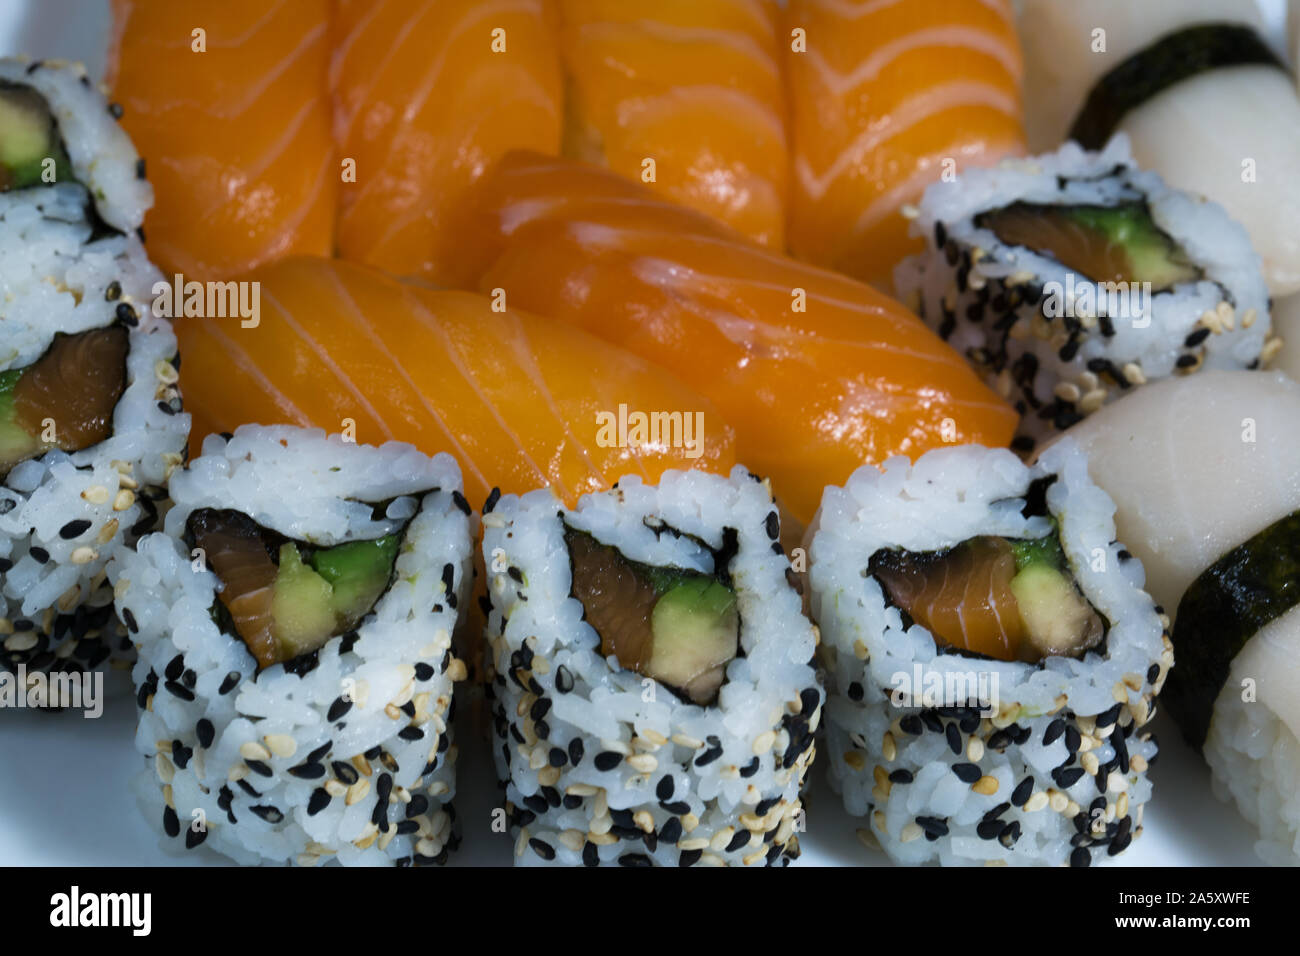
[1021,0,1300,297]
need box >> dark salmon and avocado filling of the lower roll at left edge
[0,325,130,477]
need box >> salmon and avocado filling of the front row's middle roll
[564,527,740,706]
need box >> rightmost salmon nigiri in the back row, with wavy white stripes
[785,0,1024,287]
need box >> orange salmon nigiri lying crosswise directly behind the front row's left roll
[177,258,735,503]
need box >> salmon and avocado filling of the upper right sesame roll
[975,200,1205,291]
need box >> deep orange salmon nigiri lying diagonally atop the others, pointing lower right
[462,153,1015,522]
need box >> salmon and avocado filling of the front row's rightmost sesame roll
[867,532,1106,662]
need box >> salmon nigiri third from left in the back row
[559,0,788,248]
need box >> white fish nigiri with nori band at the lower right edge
[1070,372,1300,866]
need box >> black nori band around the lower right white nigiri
[1160,511,1300,750]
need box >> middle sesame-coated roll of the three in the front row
[482,466,822,866]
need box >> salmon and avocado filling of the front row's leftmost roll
[187,509,402,669]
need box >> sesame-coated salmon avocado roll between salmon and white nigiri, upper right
[894,138,1281,453]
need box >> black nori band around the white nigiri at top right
[1069,23,1287,150]
